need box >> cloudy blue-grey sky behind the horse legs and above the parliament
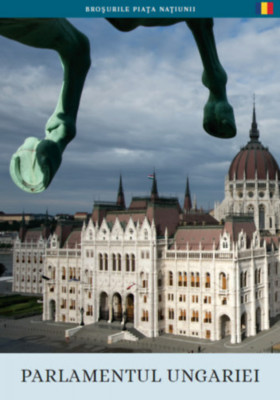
[0,19,280,214]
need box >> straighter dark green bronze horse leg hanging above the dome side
[186,18,236,138]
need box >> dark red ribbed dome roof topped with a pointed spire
[228,107,280,180]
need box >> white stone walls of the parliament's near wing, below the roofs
[43,219,280,343]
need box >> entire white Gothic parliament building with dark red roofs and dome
[13,107,280,344]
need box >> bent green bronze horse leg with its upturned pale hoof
[0,19,90,193]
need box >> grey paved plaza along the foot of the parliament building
[0,316,280,353]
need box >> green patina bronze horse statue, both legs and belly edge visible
[0,18,236,193]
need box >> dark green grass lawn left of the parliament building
[0,294,43,318]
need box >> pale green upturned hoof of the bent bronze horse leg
[10,137,61,193]
